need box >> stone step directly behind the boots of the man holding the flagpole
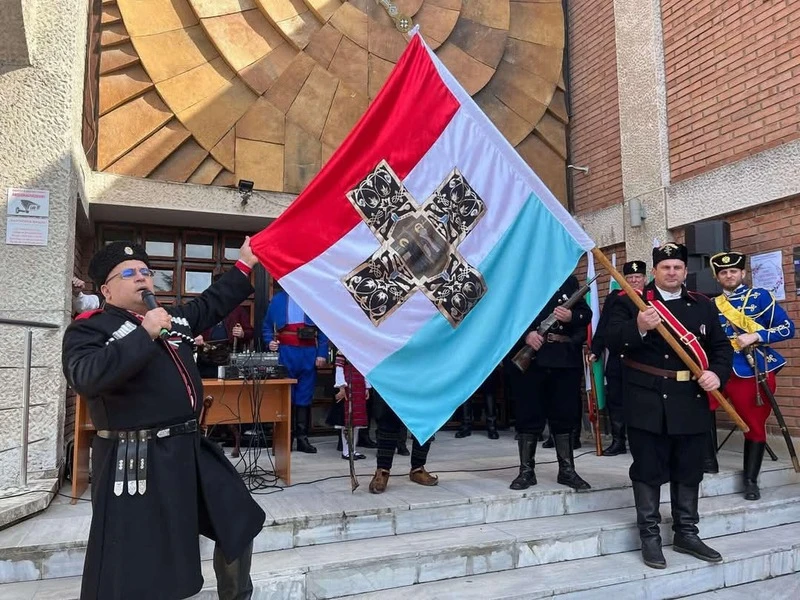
[0,484,800,599]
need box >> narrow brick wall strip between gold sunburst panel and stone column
[567,0,622,213]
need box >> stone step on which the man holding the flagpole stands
[352,523,800,600]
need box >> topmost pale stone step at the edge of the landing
[0,450,800,583]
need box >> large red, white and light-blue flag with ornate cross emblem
[252,34,594,442]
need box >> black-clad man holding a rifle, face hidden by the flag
[506,275,592,490]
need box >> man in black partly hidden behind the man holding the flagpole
[589,260,647,456]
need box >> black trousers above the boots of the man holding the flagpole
[628,426,708,486]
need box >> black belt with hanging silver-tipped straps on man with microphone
[97,419,197,496]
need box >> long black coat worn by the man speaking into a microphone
[63,269,265,600]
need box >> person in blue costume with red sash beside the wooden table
[262,290,328,454]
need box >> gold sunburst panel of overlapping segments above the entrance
[96,0,567,202]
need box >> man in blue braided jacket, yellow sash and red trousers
[710,252,794,500]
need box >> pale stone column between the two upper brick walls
[614,0,669,263]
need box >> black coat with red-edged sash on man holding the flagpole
[605,283,733,435]
